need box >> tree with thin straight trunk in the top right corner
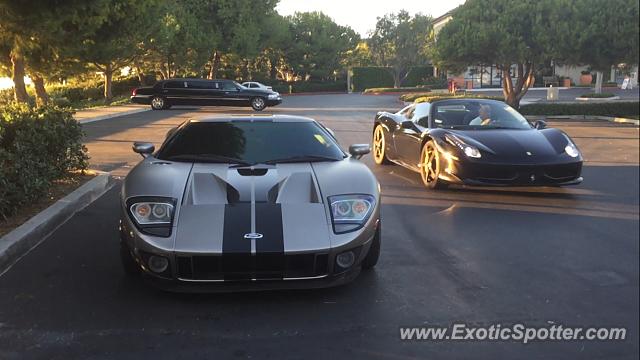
[547,0,640,93]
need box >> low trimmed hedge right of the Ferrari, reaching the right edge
[519,101,640,117]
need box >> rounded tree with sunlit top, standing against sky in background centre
[369,10,431,87]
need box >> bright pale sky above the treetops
[276,0,465,37]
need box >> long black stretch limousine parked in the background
[131,79,282,111]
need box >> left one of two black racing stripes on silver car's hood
[222,203,253,280]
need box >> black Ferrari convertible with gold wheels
[373,99,583,189]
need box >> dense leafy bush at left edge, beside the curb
[0,103,89,219]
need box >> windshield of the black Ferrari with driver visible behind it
[432,100,531,130]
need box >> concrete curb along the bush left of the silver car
[0,173,116,275]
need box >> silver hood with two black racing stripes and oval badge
[175,163,331,254]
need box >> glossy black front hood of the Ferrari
[450,129,567,161]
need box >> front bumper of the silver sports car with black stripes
[120,209,379,292]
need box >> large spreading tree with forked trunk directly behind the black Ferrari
[431,0,556,108]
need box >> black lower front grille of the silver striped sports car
[176,254,329,281]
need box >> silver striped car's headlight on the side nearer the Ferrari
[329,194,376,234]
